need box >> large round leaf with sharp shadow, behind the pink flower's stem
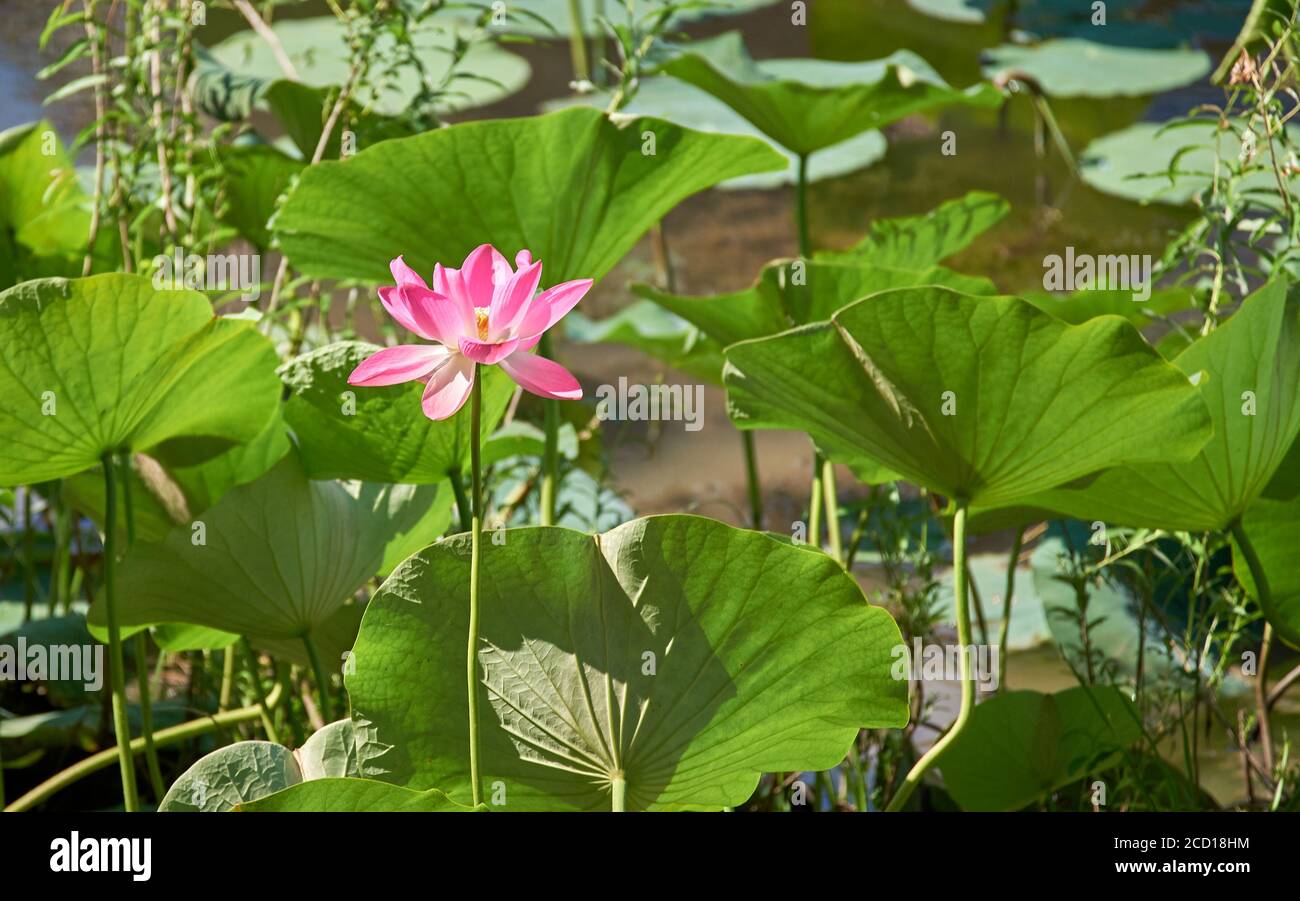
[347,516,907,810]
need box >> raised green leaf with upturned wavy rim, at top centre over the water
[662,33,1002,156]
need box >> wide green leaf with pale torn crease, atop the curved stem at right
[723,287,1210,506]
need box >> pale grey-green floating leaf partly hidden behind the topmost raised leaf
[549,76,888,191]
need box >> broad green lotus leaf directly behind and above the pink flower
[274,107,785,285]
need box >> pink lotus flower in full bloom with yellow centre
[347,244,592,419]
